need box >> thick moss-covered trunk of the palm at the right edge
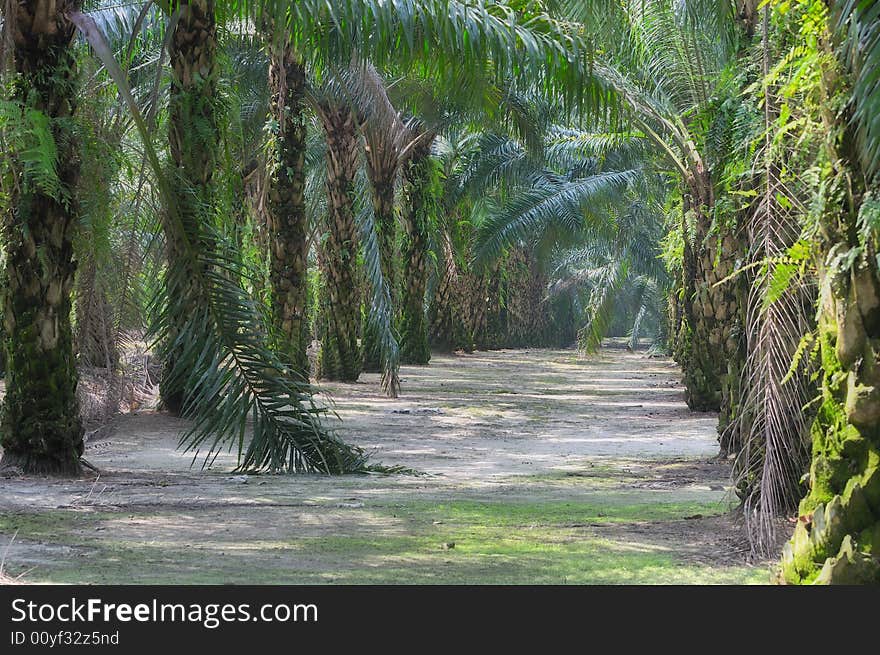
[782,30,880,584]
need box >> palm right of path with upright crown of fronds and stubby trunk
[552,0,755,440]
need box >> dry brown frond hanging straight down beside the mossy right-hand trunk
[722,6,815,555]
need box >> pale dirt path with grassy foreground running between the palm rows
[0,348,768,584]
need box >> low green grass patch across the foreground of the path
[0,500,768,584]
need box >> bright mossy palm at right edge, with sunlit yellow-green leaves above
[782,0,880,584]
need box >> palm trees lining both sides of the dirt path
[0,0,880,582]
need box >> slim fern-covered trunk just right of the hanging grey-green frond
[400,137,434,364]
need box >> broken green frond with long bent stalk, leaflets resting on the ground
[71,9,366,473]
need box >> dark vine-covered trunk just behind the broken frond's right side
[266,44,310,378]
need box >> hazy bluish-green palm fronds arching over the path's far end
[462,126,666,352]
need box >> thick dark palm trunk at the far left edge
[0,0,83,475]
